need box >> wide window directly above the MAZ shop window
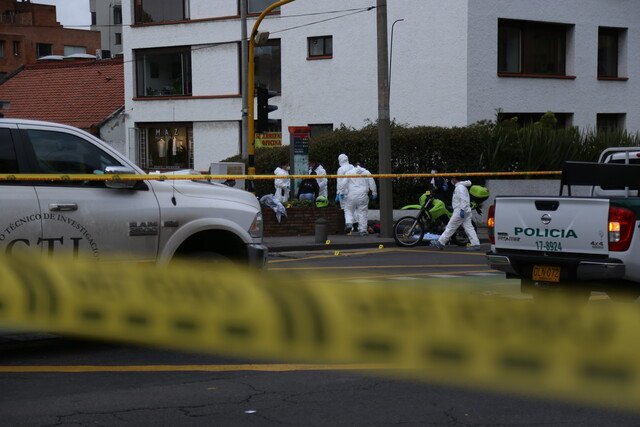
[135,47,191,97]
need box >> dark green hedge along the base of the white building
[226,113,640,207]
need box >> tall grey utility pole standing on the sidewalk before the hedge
[376,0,393,237]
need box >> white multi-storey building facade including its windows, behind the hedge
[122,0,640,170]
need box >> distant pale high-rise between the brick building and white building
[89,0,122,59]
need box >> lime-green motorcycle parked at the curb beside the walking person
[393,185,489,247]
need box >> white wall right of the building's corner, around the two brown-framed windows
[468,0,640,130]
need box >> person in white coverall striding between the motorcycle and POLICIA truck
[431,177,480,251]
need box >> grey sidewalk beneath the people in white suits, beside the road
[263,227,489,253]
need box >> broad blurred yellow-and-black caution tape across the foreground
[0,258,640,409]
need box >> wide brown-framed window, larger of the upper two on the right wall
[497,18,575,79]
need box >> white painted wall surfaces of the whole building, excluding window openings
[123,0,640,165]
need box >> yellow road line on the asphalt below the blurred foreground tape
[0,364,392,374]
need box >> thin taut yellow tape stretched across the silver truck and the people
[0,171,562,182]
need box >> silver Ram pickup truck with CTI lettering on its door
[0,119,267,267]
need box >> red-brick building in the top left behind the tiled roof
[0,0,100,78]
